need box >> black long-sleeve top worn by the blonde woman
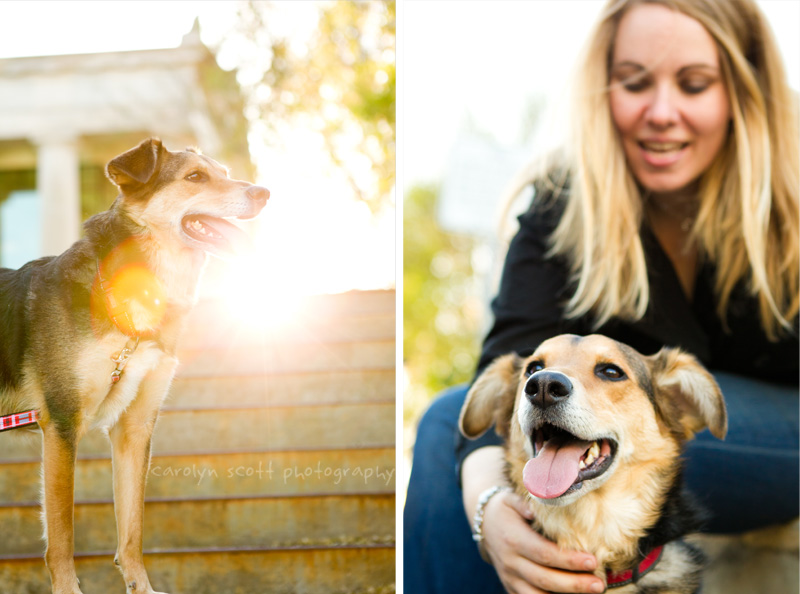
[456,188,800,468]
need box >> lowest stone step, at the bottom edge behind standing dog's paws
[0,545,395,594]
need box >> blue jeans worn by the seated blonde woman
[403,373,800,594]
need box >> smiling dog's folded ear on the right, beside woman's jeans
[646,348,728,439]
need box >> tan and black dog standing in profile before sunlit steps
[0,139,269,594]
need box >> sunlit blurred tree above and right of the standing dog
[217,0,395,212]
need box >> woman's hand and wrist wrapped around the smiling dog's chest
[461,447,605,594]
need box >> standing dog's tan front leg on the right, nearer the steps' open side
[109,359,176,594]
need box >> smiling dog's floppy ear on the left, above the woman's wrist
[458,353,522,438]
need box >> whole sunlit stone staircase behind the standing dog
[0,291,396,594]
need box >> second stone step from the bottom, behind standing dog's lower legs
[0,492,395,556]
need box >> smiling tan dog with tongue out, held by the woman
[459,335,727,594]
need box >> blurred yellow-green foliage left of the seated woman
[403,187,484,420]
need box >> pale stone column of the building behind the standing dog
[36,138,81,256]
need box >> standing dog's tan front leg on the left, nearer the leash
[41,423,81,594]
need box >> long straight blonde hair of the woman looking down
[528,0,800,340]
